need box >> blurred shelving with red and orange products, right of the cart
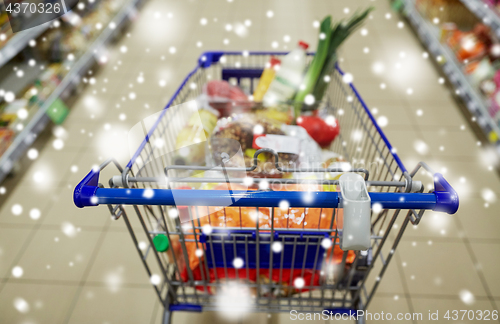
[393,0,500,155]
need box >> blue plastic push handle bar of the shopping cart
[73,170,458,214]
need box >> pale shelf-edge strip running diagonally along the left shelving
[0,0,143,183]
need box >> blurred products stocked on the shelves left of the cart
[0,0,132,156]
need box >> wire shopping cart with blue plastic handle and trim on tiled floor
[74,51,458,323]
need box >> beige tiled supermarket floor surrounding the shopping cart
[0,0,500,324]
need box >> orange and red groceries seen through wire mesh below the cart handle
[154,184,356,296]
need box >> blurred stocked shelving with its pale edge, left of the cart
[0,0,142,182]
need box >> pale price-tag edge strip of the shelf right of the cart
[403,0,500,155]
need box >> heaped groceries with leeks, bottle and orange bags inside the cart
[148,11,376,296]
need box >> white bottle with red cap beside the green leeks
[263,41,309,107]
